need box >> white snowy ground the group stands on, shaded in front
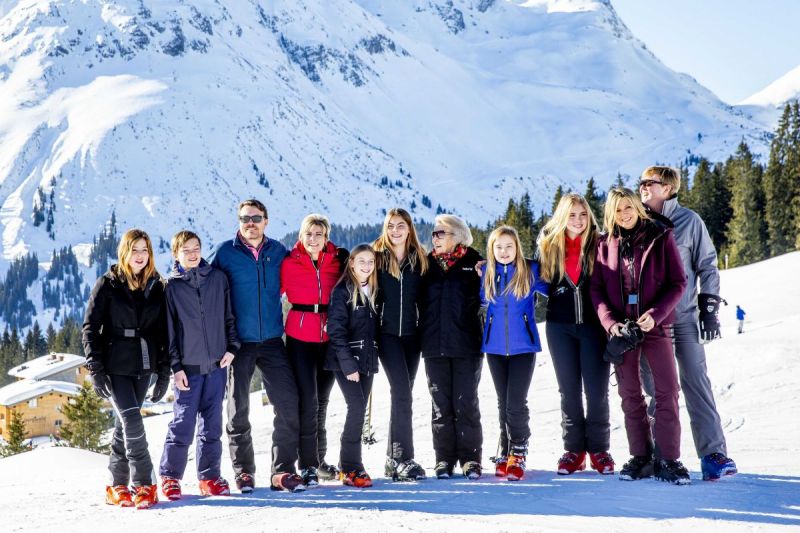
[0,253,800,533]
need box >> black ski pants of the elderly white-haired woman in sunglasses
[425,357,483,466]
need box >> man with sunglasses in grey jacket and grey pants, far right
[639,166,737,480]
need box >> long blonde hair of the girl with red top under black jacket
[537,192,599,283]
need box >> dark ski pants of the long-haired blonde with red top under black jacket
[546,322,611,453]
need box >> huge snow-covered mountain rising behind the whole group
[0,0,767,326]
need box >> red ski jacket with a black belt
[281,241,348,342]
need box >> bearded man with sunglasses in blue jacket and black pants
[212,199,305,493]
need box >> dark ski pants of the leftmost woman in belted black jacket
[108,374,156,487]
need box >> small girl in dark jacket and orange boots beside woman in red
[325,244,378,487]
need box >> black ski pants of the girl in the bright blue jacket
[486,353,536,457]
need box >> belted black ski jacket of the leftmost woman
[83,265,169,376]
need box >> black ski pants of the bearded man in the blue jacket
[226,337,300,475]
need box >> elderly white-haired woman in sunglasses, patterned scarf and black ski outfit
[420,215,483,479]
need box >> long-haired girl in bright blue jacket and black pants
[481,226,547,481]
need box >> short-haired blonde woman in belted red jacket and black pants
[281,214,347,487]
